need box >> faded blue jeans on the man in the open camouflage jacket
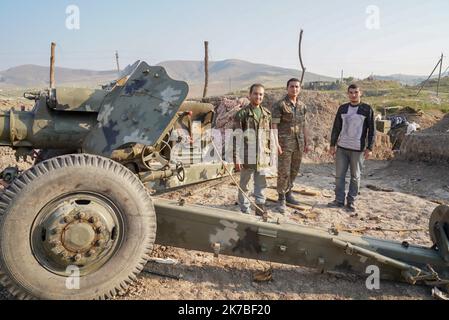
[239,168,267,212]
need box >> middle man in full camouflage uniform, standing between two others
[272,79,308,213]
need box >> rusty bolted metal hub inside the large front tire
[32,195,120,274]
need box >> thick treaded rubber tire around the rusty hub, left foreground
[0,154,156,300]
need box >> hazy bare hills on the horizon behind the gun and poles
[0,60,335,97]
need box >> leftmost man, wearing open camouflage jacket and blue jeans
[233,84,271,216]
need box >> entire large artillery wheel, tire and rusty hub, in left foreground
[0,154,156,299]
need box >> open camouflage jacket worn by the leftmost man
[233,105,271,171]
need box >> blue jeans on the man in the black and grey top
[335,148,365,203]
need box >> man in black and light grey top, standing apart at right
[329,84,376,212]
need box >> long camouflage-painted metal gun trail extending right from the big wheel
[154,199,449,285]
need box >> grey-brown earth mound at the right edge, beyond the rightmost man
[401,114,449,162]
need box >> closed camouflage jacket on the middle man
[272,96,307,150]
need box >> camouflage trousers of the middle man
[277,148,303,194]
